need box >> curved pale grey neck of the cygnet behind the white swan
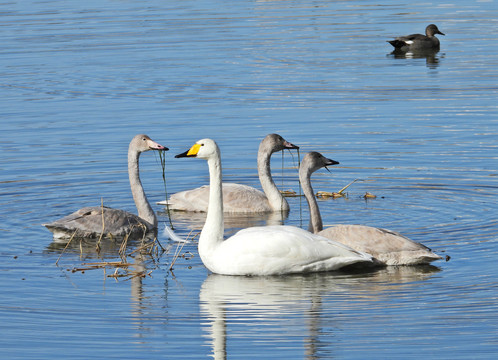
[258,147,289,211]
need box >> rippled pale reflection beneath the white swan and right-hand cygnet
[199,265,440,359]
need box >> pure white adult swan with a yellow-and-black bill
[176,139,372,275]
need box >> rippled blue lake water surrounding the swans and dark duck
[0,0,498,359]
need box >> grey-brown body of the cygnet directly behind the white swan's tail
[318,225,441,265]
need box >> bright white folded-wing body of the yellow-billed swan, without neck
[208,226,372,275]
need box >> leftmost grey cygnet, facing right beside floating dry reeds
[44,134,168,240]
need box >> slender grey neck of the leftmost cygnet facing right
[128,149,157,228]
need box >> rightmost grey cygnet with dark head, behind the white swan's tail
[299,152,441,265]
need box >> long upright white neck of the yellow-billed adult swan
[199,153,224,270]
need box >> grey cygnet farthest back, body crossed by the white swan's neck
[158,134,299,213]
